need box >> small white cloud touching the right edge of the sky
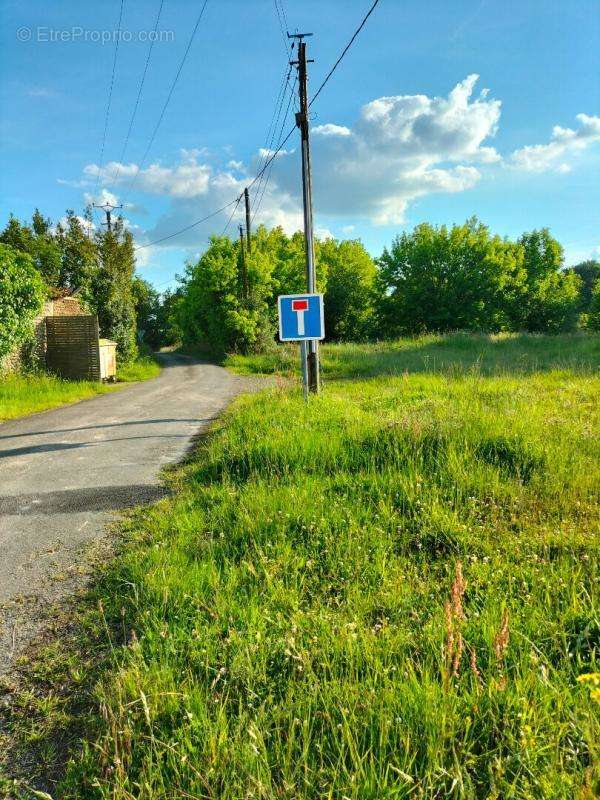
[509,114,600,172]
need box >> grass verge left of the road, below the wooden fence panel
[0,357,160,422]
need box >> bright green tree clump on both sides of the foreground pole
[179,227,376,353]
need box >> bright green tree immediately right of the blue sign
[317,239,377,341]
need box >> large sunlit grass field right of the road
[4,335,600,800]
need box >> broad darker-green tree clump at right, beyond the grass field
[379,218,579,336]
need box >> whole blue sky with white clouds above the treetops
[0,0,600,288]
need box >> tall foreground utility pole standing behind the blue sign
[288,33,320,394]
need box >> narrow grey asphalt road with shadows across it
[0,355,252,674]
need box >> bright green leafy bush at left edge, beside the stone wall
[0,243,46,359]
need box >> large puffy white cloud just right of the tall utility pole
[276,75,500,224]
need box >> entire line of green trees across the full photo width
[0,209,600,361]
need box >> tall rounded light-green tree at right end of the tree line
[515,228,581,333]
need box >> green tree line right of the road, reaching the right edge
[171,218,600,352]
